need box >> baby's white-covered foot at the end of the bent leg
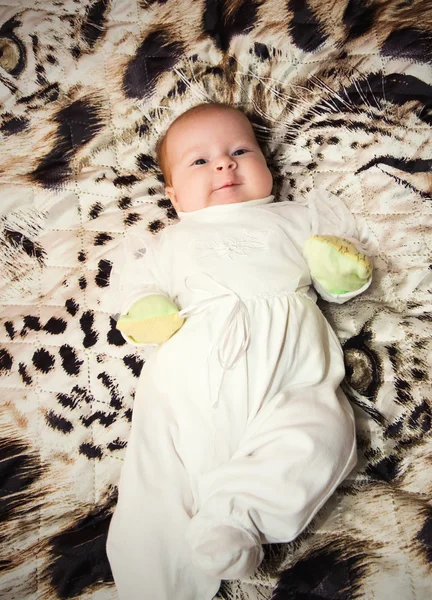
[187,519,264,579]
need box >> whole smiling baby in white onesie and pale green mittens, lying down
[107,104,372,600]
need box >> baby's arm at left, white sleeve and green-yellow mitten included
[112,234,184,345]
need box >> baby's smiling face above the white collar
[166,108,273,212]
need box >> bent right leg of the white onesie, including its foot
[188,385,356,568]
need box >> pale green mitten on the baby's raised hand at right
[303,235,372,294]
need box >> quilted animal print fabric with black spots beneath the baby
[0,0,432,600]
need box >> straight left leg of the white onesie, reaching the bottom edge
[107,372,220,600]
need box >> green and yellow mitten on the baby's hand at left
[117,295,184,344]
